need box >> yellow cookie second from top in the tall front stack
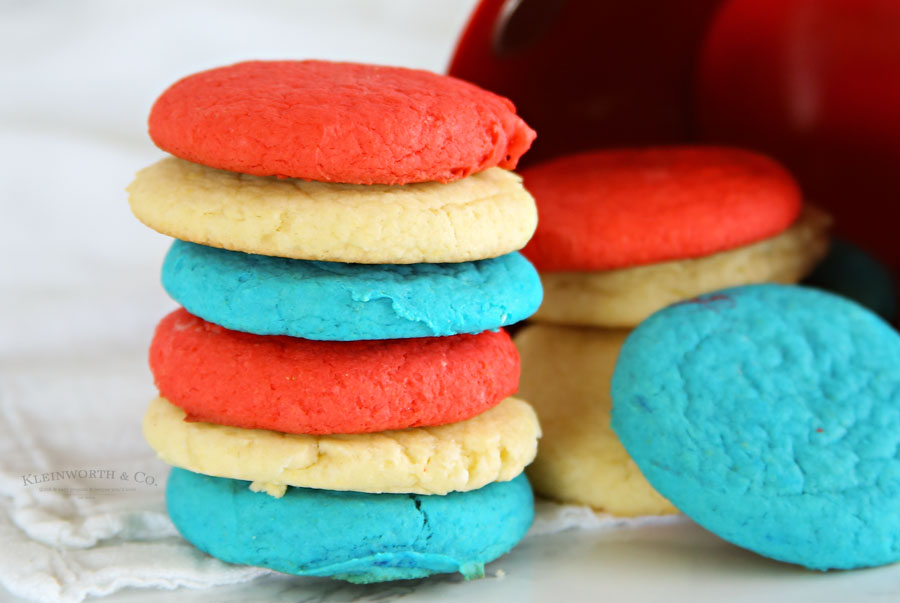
[128,157,537,264]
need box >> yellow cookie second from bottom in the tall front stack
[144,398,541,497]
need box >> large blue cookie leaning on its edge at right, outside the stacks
[612,285,900,570]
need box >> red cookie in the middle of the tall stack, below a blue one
[150,309,519,434]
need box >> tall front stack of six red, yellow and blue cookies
[129,61,541,583]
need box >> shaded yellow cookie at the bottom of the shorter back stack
[515,324,677,516]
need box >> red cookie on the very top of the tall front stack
[150,61,535,184]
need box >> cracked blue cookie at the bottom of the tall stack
[166,468,534,583]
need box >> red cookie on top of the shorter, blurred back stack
[522,147,802,271]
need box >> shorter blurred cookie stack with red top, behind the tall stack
[516,147,830,516]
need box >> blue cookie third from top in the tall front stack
[162,241,543,341]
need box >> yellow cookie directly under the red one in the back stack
[532,206,831,327]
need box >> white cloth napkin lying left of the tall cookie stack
[0,342,274,602]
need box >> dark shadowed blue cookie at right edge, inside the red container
[805,239,897,320]
